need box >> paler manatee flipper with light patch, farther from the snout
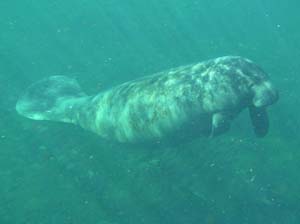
[210,113,230,137]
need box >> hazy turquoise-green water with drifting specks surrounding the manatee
[0,0,300,224]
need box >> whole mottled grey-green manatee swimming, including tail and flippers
[16,56,278,142]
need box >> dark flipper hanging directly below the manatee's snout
[249,106,269,137]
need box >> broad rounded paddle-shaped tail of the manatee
[16,76,86,123]
